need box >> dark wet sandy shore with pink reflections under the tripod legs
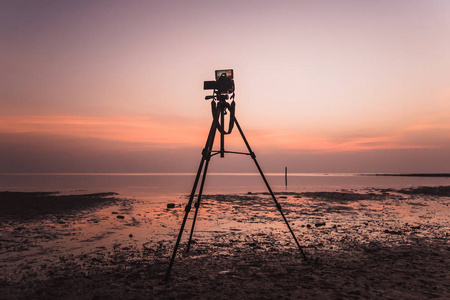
[0,187,450,299]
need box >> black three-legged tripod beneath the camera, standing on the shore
[165,93,306,280]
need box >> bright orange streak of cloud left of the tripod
[0,115,207,149]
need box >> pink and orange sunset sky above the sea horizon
[0,0,450,173]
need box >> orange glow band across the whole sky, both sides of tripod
[0,115,449,153]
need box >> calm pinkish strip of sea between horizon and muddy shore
[0,173,450,197]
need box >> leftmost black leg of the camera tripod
[165,121,216,280]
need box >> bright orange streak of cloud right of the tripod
[246,117,450,153]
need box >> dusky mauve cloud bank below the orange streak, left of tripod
[0,133,200,173]
